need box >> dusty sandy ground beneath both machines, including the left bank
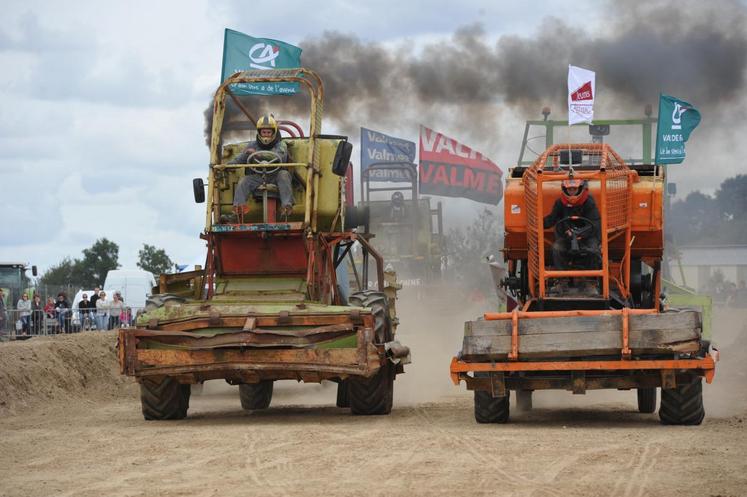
[0,294,747,497]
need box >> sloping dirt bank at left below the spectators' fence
[0,331,136,413]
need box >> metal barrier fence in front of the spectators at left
[0,306,141,340]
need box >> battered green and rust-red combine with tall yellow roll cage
[118,69,409,420]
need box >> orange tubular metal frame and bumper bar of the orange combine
[450,144,715,387]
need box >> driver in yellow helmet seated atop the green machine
[231,114,293,216]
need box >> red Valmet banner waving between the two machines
[419,126,503,205]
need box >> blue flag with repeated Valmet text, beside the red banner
[361,128,415,182]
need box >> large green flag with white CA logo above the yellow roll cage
[221,29,301,95]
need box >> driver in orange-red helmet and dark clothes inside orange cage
[544,177,601,269]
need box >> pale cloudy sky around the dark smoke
[0,0,747,271]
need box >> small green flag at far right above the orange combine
[656,95,700,164]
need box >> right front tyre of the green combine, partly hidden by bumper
[348,290,395,415]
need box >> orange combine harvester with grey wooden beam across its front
[450,144,715,425]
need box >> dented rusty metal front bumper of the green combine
[118,315,392,383]
